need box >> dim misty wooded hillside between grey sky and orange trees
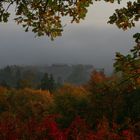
[0,64,104,87]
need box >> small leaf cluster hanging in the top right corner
[108,0,140,30]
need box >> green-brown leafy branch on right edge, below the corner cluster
[114,33,140,85]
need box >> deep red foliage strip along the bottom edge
[0,115,136,140]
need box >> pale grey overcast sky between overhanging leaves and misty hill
[0,2,140,72]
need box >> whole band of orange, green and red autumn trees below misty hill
[0,71,140,140]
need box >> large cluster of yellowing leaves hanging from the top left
[0,0,92,39]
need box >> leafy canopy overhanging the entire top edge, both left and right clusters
[0,0,140,39]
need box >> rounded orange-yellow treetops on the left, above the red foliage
[0,88,54,119]
